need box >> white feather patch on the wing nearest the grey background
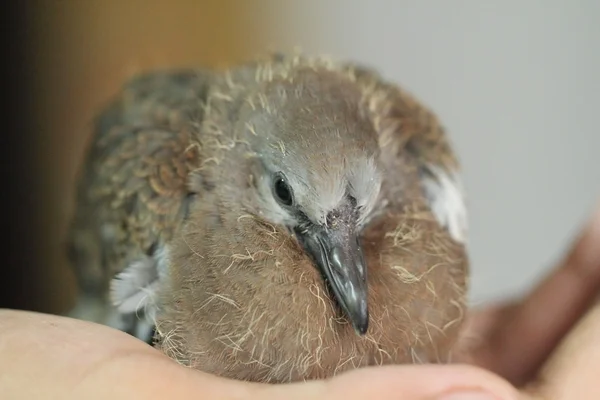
[423,165,468,244]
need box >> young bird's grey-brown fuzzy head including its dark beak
[234,69,382,335]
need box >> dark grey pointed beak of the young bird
[296,223,369,336]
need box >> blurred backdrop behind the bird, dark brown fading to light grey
[5,0,600,313]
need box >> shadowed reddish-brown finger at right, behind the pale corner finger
[475,202,600,385]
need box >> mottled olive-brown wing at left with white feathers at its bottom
[68,70,212,314]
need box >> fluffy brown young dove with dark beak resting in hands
[67,52,470,383]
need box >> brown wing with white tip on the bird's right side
[345,65,468,244]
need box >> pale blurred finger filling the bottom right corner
[528,303,600,400]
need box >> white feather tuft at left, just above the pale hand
[110,242,168,322]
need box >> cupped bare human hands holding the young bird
[0,202,600,400]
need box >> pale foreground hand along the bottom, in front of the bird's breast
[0,311,518,400]
